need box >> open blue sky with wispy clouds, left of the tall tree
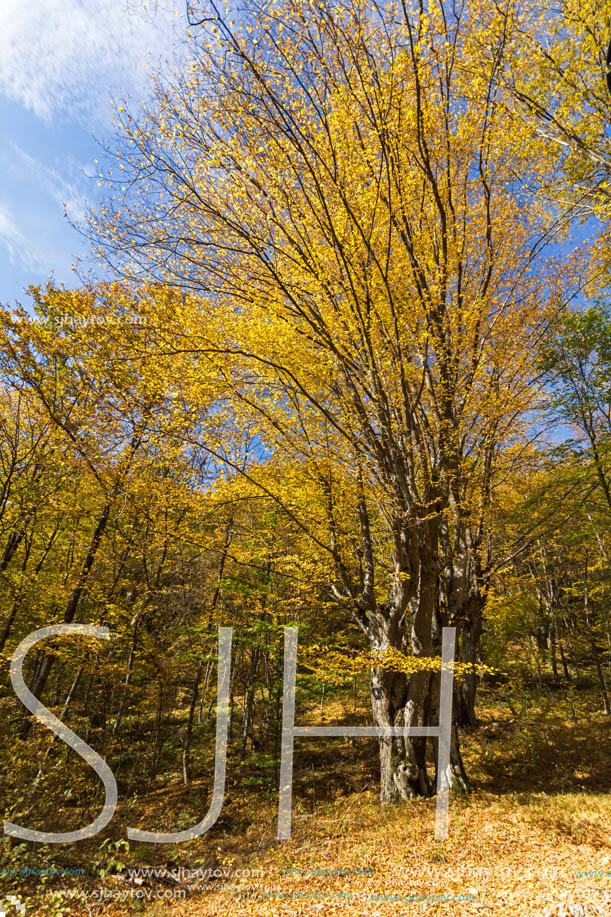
[0,0,186,307]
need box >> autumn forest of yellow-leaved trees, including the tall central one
[0,0,611,908]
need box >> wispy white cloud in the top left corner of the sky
[0,0,184,125]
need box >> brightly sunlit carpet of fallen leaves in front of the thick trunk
[151,776,611,917]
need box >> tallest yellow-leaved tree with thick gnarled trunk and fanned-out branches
[91,0,584,801]
